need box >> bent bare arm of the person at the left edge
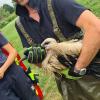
[0,43,17,73]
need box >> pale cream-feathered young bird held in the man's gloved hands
[41,38,82,73]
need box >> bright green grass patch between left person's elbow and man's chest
[1,19,22,54]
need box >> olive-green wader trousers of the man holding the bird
[56,76,100,100]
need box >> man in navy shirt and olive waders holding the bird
[14,0,100,100]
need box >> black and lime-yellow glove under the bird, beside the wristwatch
[58,55,82,80]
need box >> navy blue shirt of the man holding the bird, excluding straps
[16,0,86,47]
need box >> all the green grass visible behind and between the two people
[2,0,100,100]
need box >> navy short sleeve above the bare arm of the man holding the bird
[58,0,87,25]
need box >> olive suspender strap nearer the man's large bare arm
[47,0,67,41]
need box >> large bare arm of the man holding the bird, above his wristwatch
[75,10,100,70]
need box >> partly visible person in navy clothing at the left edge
[0,33,39,100]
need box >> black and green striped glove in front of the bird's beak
[24,45,46,64]
